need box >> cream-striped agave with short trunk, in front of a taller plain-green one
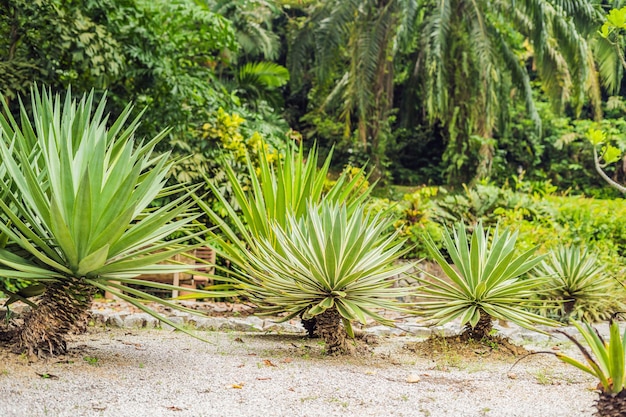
[245,200,410,353]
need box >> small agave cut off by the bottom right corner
[555,318,626,417]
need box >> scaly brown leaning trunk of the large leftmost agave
[17,278,95,356]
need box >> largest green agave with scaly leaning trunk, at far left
[0,91,224,355]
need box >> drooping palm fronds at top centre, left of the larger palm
[287,0,418,176]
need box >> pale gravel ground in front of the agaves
[0,306,596,417]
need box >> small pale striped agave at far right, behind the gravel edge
[533,246,620,322]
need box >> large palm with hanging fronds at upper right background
[400,0,600,183]
